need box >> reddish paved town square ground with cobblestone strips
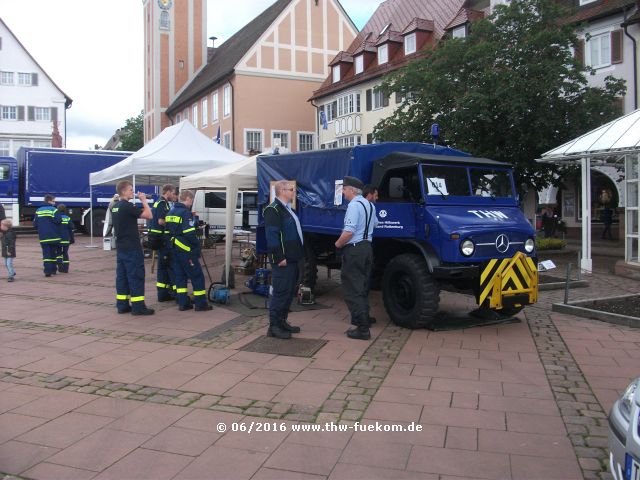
[0,237,640,480]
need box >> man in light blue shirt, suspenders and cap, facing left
[335,177,378,340]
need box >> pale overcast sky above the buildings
[0,0,381,149]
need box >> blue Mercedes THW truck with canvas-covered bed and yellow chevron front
[257,142,538,328]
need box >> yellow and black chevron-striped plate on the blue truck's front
[477,252,538,310]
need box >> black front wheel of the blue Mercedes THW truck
[382,253,440,328]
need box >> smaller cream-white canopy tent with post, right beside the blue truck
[180,155,258,285]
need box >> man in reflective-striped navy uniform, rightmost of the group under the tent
[165,190,212,312]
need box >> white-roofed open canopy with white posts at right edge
[538,110,640,272]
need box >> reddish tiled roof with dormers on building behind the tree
[311,0,464,99]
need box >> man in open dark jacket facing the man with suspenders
[263,180,304,339]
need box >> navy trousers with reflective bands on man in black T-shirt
[116,250,145,312]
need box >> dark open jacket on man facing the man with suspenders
[263,199,304,265]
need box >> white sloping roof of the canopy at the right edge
[539,110,640,162]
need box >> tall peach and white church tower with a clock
[142,0,207,143]
